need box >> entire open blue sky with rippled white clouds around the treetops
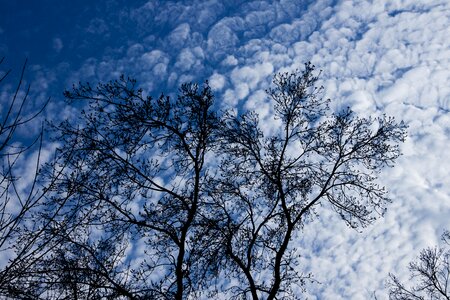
[0,0,450,299]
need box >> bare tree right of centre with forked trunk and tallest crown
[208,64,405,300]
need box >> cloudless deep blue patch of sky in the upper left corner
[0,0,145,74]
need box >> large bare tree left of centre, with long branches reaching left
[29,77,219,299]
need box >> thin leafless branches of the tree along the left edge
[0,58,54,295]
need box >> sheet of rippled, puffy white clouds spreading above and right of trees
[33,0,450,299]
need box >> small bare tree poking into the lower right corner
[388,231,450,300]
